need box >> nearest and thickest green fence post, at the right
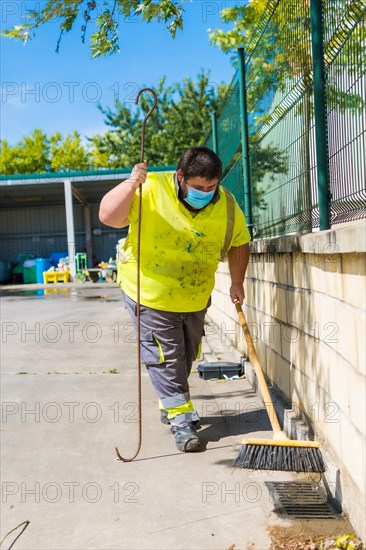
[310,0,330,230]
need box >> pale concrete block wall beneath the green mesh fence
[208,222,366,538]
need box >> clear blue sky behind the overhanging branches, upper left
[1,0,234,144]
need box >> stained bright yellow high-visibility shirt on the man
[119,172,250,313]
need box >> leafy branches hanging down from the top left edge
[3,0,184,57]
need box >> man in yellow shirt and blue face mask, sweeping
[99,147,250,452]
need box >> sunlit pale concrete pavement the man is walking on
[1,284,354,550]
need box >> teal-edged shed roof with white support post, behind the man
[0,166,176,278]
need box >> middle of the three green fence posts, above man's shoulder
[238,48,253,237]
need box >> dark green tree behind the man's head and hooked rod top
[90,72,218,168]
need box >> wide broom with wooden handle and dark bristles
[235,302,325,472]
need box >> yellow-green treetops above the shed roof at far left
[0,129,91,175]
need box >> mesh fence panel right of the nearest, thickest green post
[324,0,366,223]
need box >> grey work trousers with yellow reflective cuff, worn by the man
[124,294,207,424]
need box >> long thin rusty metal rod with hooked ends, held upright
[115,88,158,462]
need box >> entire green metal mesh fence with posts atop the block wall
[206,0,366,238]
